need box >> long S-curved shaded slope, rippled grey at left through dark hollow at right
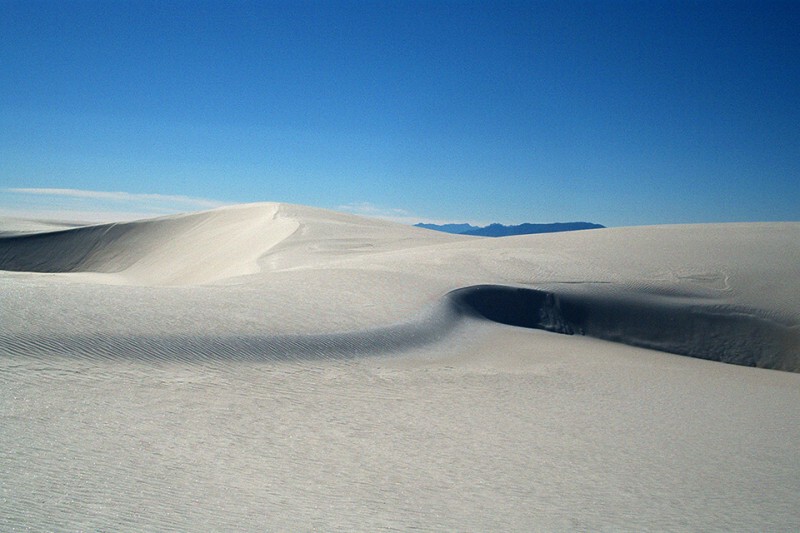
[0,285,800,372]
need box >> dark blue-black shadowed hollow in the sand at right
[450,285,800,372]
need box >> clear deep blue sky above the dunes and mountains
[0,0,800,226]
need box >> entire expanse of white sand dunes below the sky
[0,204,800,531]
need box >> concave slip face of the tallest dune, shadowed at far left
[3,205,298,284]
